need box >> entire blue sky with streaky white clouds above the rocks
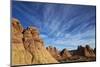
[12,1,96,49]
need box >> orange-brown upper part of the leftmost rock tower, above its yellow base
[11,19,23,43]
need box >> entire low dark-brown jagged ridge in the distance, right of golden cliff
[46,45,96,62]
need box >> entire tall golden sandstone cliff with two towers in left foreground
[11,19,58,65]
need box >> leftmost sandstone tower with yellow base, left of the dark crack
[11,19,32,65]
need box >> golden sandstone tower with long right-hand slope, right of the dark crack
[23,27,58,64]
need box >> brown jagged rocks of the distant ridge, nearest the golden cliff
[46,46,71,62]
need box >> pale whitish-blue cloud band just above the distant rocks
[41,27,95,49]
